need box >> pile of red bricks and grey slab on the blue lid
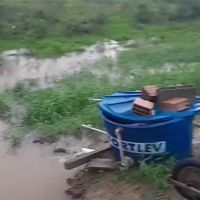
[133,85,196,116]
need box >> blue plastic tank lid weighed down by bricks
[99,91,200,123]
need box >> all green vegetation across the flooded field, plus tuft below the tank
[0,0,200,189]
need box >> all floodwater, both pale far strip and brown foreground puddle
[0,41,123,200]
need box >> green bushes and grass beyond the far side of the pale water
[0,0,200,56]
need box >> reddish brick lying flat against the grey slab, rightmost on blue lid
[161,98,190,112]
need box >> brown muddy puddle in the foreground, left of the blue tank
[0,122,94,200]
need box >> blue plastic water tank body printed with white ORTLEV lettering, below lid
[101,114,193,162]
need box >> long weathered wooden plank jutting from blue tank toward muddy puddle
[64,143,110,170]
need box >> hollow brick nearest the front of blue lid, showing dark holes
[133,98,154,116]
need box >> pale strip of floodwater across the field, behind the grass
[0,41,123,90]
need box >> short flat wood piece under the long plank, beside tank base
[88,158,116,170]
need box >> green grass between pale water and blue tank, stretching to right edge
[1,22,200,136]
